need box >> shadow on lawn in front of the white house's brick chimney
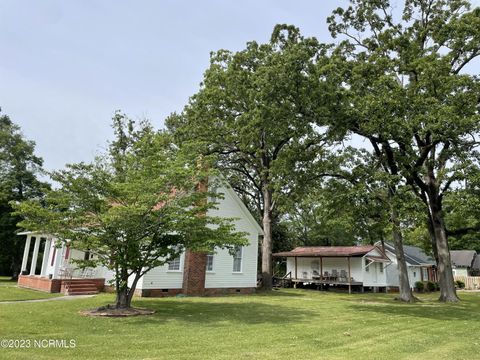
[129,299,316,326]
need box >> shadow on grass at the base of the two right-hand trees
[349,299,480,321]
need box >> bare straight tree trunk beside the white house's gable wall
[262,184,272,290]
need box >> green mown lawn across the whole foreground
[0,289,480,359]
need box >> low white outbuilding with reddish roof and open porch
[274,245,391,293]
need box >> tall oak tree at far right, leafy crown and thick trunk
[325,0,480,302]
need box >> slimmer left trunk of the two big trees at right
[388,189,415,302]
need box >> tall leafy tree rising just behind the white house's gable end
[167,25,325,289]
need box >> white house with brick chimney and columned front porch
[18,184,263,296]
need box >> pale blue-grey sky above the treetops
[0,0,480,170]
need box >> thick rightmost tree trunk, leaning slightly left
[429,198,459,302]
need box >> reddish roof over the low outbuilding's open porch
[273,245,375,257]
